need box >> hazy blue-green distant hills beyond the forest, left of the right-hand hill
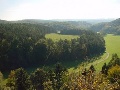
[0,19,92,30]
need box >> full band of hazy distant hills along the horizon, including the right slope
[0,18,120,34]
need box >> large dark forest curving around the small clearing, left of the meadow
[0,24,105,71]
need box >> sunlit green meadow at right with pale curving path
[79,34,120,71]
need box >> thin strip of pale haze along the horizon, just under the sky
[0,18,115,24]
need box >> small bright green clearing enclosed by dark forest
[45,33,79,41]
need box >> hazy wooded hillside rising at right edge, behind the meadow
[89,18,120,35]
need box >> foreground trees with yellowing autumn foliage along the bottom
[0,54,120,90]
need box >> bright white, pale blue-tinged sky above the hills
[0,0,120,21]
